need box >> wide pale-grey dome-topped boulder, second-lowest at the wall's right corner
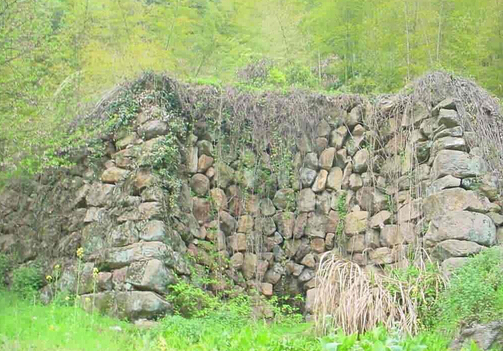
[425,211,496,246]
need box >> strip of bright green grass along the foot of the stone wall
[0,291,456,351]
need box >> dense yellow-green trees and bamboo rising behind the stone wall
[0,0,503,182]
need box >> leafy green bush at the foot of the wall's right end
[437,247,503,330]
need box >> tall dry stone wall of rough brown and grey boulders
[0,84,503,319]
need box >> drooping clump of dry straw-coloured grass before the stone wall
[314,252,444,335]
